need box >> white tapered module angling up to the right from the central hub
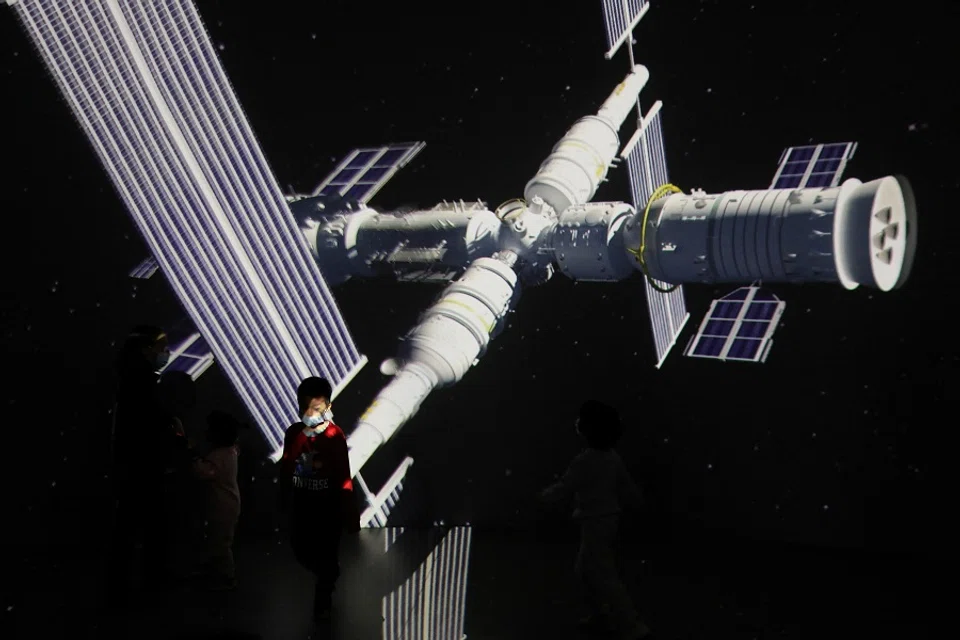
[523,65,650,214]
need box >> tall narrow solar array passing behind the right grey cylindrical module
[620,100,690,368]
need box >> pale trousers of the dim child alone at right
[574,515,637,631]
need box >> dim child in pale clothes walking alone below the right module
[541,400,650,640]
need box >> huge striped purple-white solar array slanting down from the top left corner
[14,0,365,460]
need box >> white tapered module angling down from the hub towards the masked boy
[347,258,518,474]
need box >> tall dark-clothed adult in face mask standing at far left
[107,325,187,604]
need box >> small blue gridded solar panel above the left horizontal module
[313,142,426,203]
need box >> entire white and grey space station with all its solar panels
[7,0,917,524]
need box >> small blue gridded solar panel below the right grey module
[684,287,787,362]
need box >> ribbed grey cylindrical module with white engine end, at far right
[627,176,917,291]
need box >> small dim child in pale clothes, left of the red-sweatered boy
[194,411,242,590]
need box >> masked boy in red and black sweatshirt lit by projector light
[280,377,360,622]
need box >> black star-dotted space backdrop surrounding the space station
[0,0,960,636]
